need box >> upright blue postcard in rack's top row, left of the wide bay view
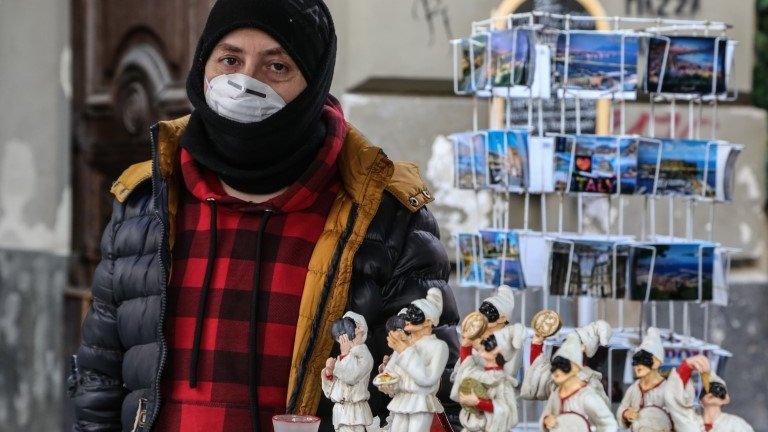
[490,28,535,87]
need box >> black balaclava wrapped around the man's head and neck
[181,0,336,194]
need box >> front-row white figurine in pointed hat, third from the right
[540,333,618,432]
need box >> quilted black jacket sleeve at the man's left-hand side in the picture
[68,197,130,432]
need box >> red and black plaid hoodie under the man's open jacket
[155,98,347,432]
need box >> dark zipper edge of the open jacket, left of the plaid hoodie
[145,124,167,431]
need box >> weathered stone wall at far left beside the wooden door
[0,0,71,432]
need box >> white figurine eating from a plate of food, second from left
[382,288,448,432]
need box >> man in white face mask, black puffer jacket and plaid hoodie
[71,0,458,431]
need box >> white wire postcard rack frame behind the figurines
[451,12,739,430]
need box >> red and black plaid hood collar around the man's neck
[180,95,347,213]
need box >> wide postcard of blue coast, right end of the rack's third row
[630,242,715,301]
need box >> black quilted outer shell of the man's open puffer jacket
[69,119,459,431]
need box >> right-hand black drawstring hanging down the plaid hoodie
[248,209,273,432]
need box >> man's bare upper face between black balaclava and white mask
[203,28,307,103]
